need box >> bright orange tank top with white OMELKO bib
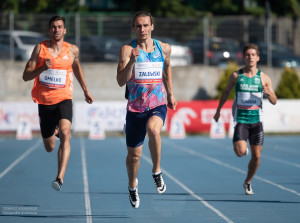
[31,40,73,105]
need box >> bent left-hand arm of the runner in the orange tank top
[23,44,52,81]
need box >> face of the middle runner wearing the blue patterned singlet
[133,16,154,40]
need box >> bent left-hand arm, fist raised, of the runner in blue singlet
[117,44,140,87]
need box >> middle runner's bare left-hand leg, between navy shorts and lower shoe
[126,145,143,188]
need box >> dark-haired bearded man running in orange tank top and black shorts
[23,16,94,191]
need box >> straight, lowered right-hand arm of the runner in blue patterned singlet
[160,42,177,110]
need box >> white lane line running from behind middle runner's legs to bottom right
[142,155,233,223]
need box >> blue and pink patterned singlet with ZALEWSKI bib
[127,39,166,112]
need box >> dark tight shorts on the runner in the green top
[233,122,264,146]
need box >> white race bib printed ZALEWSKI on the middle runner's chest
[134,62,163,84]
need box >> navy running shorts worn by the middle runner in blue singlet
[126,105,167,148]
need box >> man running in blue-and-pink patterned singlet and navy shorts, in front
[117,12,177,208]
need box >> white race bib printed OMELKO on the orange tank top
[39,69,67,88]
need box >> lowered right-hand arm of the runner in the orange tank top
[70,45,94,104]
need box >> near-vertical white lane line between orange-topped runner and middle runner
[80,138,93,223]
